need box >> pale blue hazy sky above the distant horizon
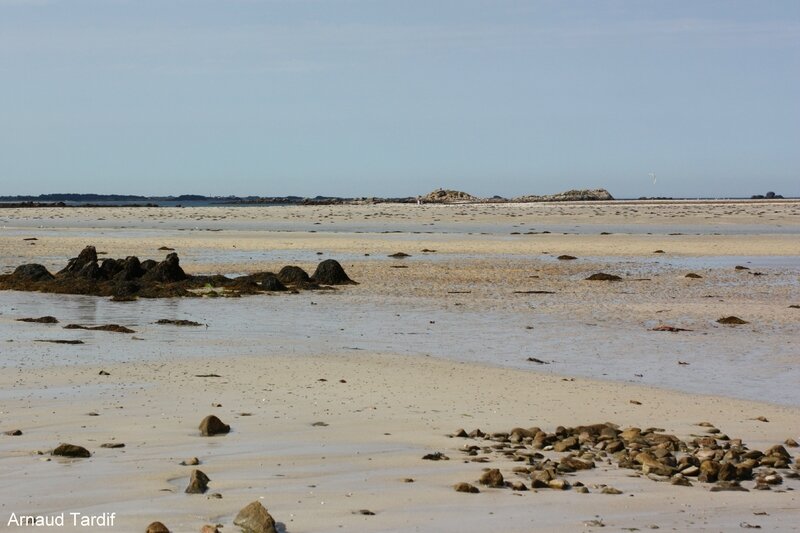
[0,0,800,198]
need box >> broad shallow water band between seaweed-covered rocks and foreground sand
[0,290,800,406]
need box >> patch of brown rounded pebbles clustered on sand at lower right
[446,422,800,494]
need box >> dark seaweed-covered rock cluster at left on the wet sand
[0,246,355,301]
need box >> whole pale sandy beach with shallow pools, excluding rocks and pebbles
[0,201,800,533]
